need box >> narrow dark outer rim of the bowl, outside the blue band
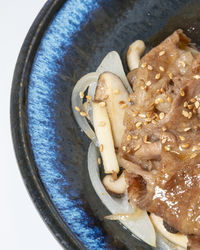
[10,0,84,249]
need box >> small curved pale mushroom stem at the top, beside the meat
[127,40,145,71]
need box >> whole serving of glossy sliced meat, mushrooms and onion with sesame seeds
[72,29,200,249]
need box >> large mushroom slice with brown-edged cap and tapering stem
[95,72,129,148]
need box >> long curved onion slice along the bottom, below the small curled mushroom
[88,143,156,246]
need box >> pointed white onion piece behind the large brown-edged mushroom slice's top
[96,51,133,93]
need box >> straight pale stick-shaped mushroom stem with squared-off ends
[92,102,119,174]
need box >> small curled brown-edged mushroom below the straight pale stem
[102,173,127,195]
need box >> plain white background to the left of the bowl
[0,0,62,250]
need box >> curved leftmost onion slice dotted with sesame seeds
[71,72,99,141]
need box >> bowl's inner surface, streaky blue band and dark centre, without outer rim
[24,0,200,249]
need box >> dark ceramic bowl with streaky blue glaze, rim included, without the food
[11,0,200,249]
